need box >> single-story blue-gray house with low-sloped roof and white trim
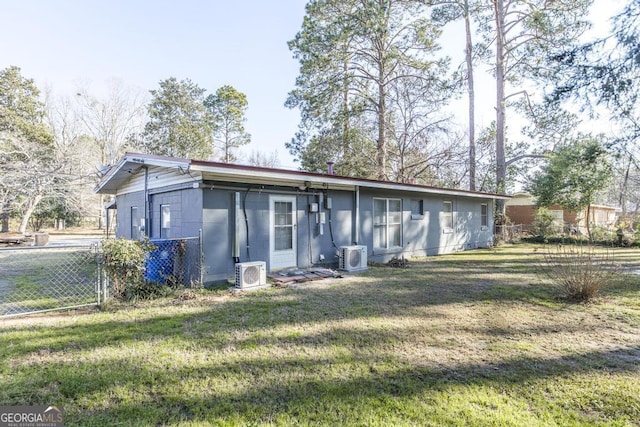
[95,153,508,282]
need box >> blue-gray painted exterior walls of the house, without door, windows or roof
[117,182,493,283]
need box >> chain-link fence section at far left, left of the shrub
[0,244,102,317]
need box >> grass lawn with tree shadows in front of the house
[0,245,640,426]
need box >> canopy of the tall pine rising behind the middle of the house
[286,0,448,179]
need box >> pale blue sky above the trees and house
[0,0,618,168]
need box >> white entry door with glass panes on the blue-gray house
[269,196,298,270]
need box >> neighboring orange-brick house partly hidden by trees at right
[505,193,616,234]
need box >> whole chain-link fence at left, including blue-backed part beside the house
[0,237,203,317]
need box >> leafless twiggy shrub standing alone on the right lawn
[540,244,619,301]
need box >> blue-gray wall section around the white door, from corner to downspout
[203,187,353,282]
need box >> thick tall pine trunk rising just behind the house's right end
[493,0,507,215]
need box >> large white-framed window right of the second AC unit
[373,199,402,249]
